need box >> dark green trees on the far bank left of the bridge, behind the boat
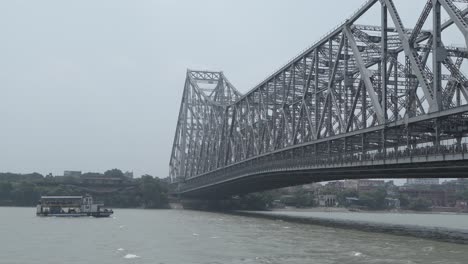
[0,169,169,209]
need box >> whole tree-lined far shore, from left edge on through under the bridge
[0,169,468,213]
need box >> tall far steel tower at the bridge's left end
[169,70,241,180]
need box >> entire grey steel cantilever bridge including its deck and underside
[169,0,468,198]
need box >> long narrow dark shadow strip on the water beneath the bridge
[232,211,468,244]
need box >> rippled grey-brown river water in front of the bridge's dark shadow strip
[0,207,468,264]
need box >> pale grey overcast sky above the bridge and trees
[0,0,463,177]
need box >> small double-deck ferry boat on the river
[36,194,114,217]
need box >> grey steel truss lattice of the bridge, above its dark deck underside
[170,0,468,194]
